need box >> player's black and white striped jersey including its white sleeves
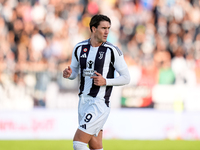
[70,39,129,103]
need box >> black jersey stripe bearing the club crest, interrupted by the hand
[88,46,107,97]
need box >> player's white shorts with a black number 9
[78,95,110,136]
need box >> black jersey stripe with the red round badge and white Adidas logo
[79,44,90,95]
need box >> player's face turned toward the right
[94,21,110,43]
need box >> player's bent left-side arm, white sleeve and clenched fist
[63,46,79,80]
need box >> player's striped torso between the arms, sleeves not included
[77,44,114,99]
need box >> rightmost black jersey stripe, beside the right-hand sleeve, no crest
[104,48,115,106]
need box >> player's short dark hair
[90,14,111,32]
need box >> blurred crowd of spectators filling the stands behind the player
[0,0,200,109]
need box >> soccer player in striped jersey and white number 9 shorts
[63,14,130,150]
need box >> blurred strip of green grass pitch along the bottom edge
[0,140,200,150]
